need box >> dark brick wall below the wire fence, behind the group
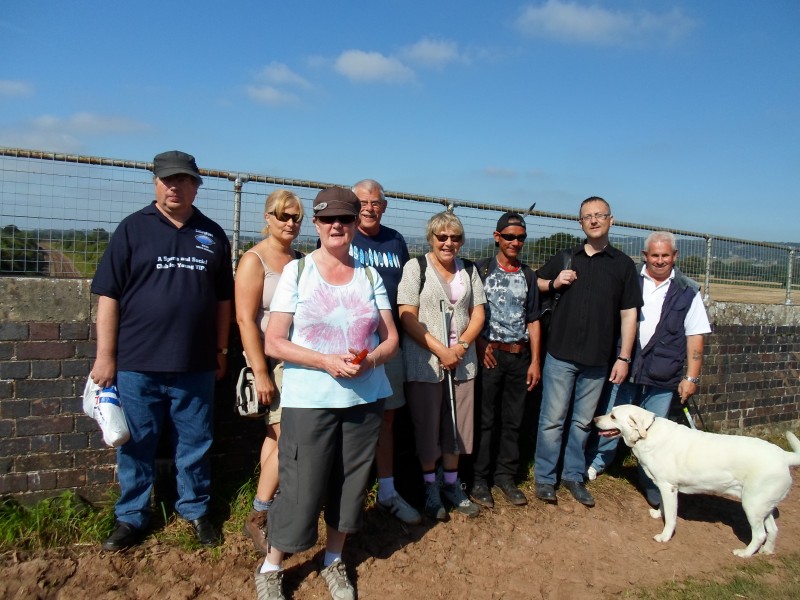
[0,278,800,502]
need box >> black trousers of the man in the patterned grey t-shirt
[473,349,531,483]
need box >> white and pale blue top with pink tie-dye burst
[270,253,392,408]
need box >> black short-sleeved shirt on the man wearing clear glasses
[537,244,643,367]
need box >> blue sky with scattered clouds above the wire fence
[0,0,800,242]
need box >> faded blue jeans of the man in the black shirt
[534,354,608,485]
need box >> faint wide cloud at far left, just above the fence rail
[0,113,151,152]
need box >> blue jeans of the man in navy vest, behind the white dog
[586,382,674,506]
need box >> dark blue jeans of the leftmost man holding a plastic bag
[114,371,214,528]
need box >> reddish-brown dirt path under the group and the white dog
[0,476,800,600]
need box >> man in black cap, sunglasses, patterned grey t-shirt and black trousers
[470,212,541,508]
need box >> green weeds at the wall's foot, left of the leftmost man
[0,492,114,551]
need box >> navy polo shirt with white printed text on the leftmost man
[91,202,233,372]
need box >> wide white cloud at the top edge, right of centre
[515,0,695,45]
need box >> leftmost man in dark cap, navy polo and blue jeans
[91,151,233,550]
